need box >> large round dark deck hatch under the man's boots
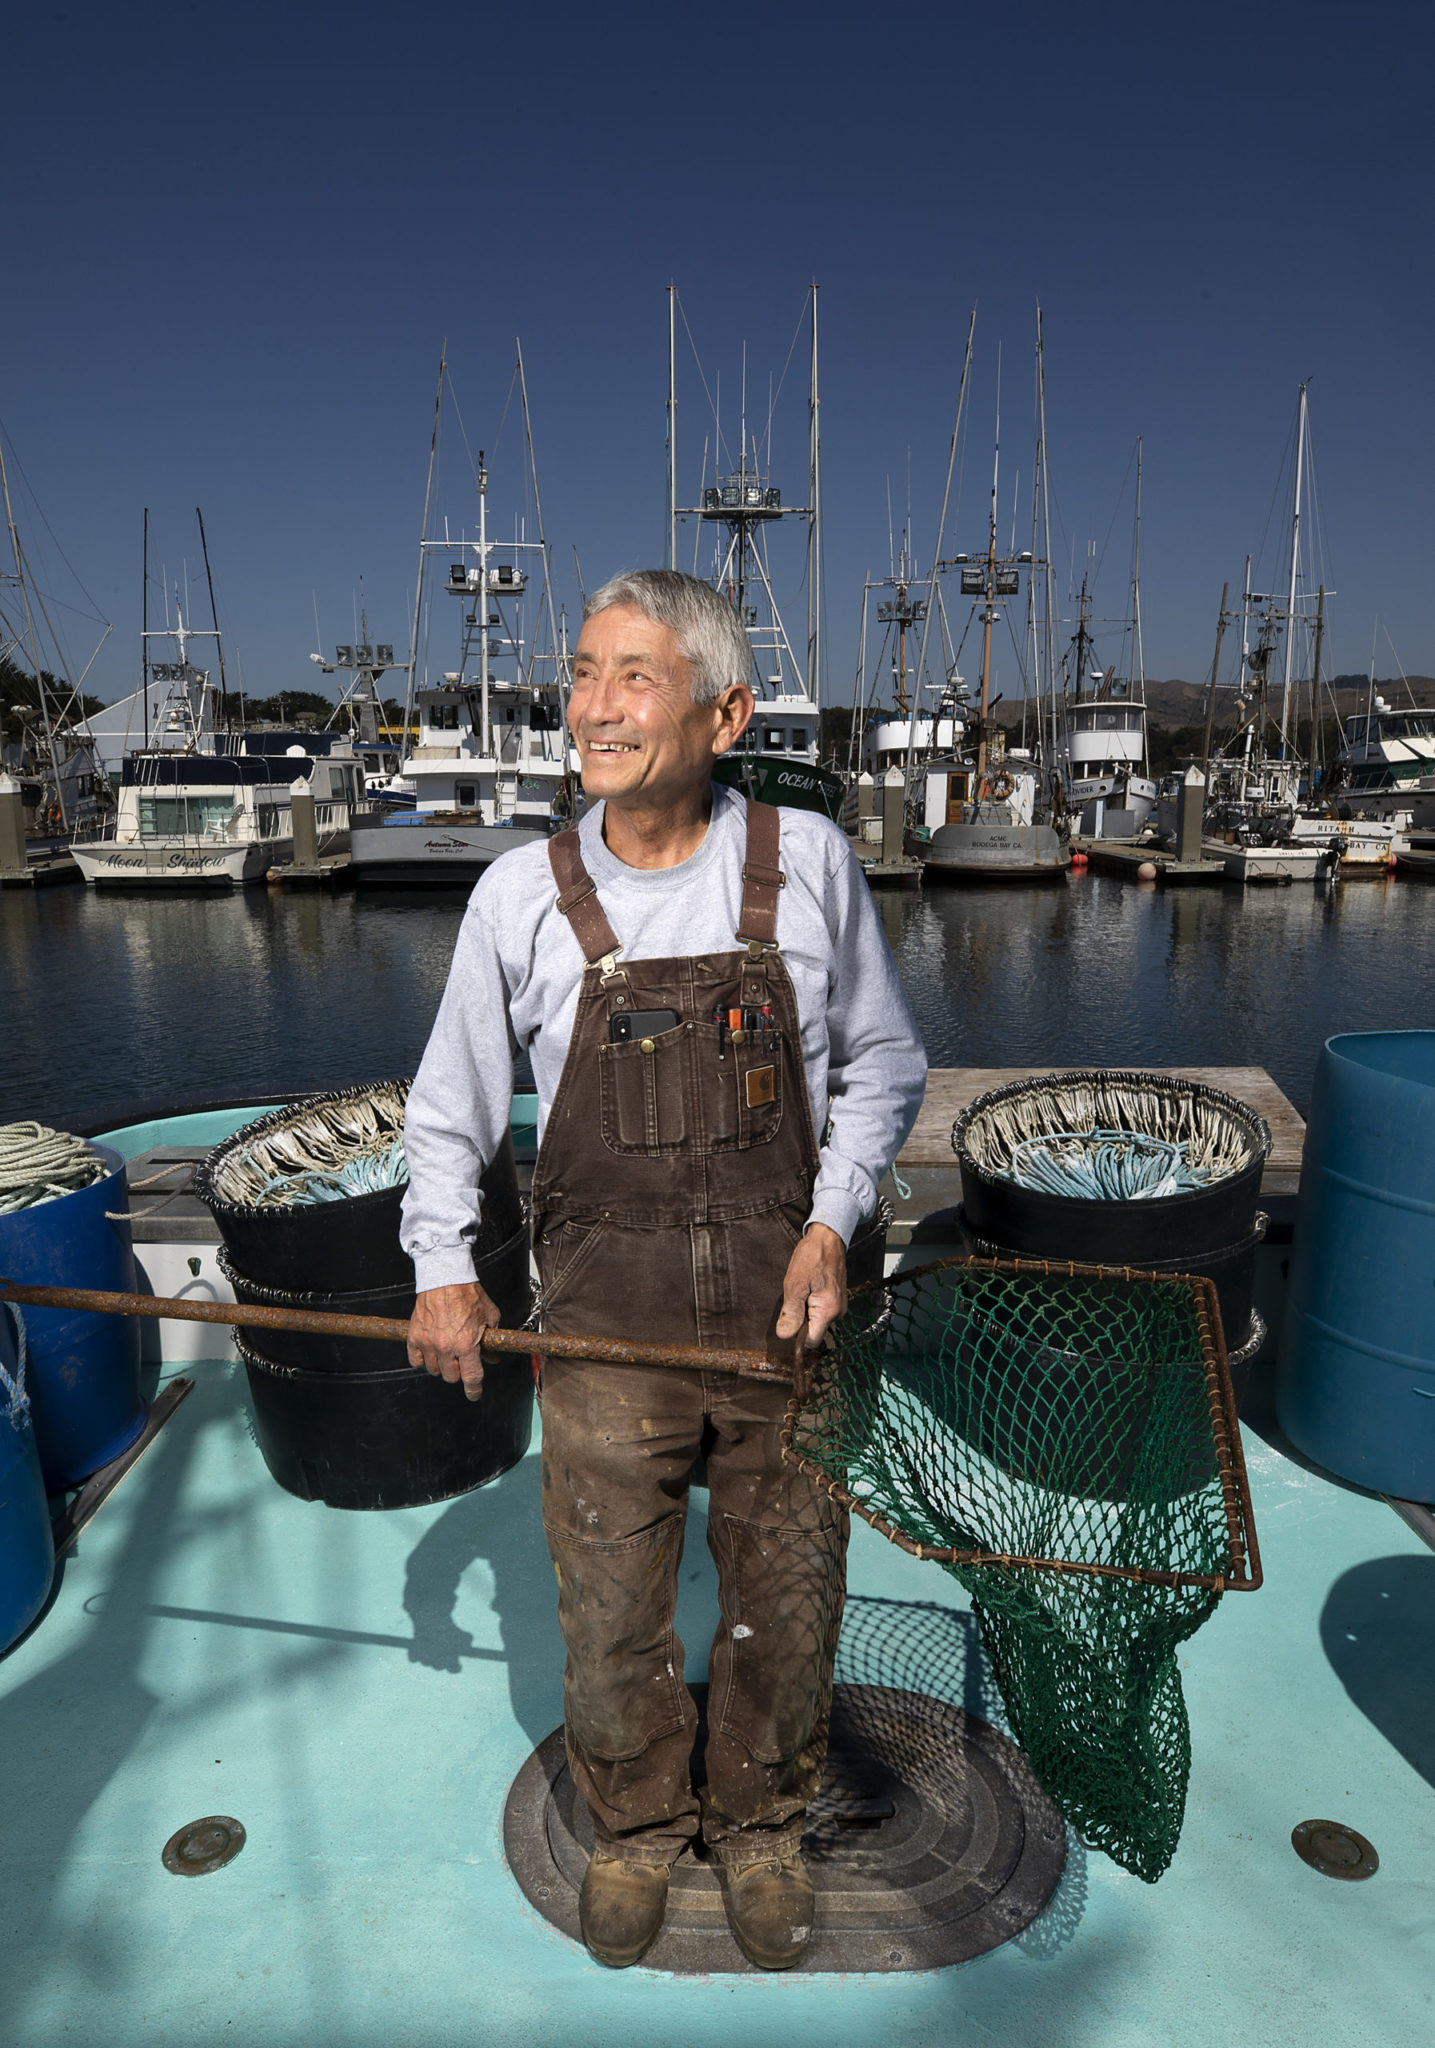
[504,1686,1067,1974]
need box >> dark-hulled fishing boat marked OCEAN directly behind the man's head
[665,285,843,819]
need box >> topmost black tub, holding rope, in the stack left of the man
[194,1079,524,1294]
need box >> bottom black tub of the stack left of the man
[235,1337,532,1509]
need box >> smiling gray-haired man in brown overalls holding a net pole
[403,569,925,1970]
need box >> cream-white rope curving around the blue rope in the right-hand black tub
[964,1073,1255,1192]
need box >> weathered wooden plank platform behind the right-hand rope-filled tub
[882,1061,1306,1245]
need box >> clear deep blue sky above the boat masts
[0,0,1435,698]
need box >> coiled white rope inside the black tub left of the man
[213,1085,409,1208]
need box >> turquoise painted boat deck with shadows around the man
[0,1137,1435,2048]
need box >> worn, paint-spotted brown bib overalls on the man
[532,803,855,1866]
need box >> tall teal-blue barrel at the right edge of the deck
[1277,1030,1435,1501]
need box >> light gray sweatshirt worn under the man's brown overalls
[401,784,927,1290]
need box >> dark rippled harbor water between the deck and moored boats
[0,872,1435,1122]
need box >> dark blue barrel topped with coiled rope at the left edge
[0,1145,145,1493]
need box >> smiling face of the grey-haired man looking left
[567,604,753,809]
